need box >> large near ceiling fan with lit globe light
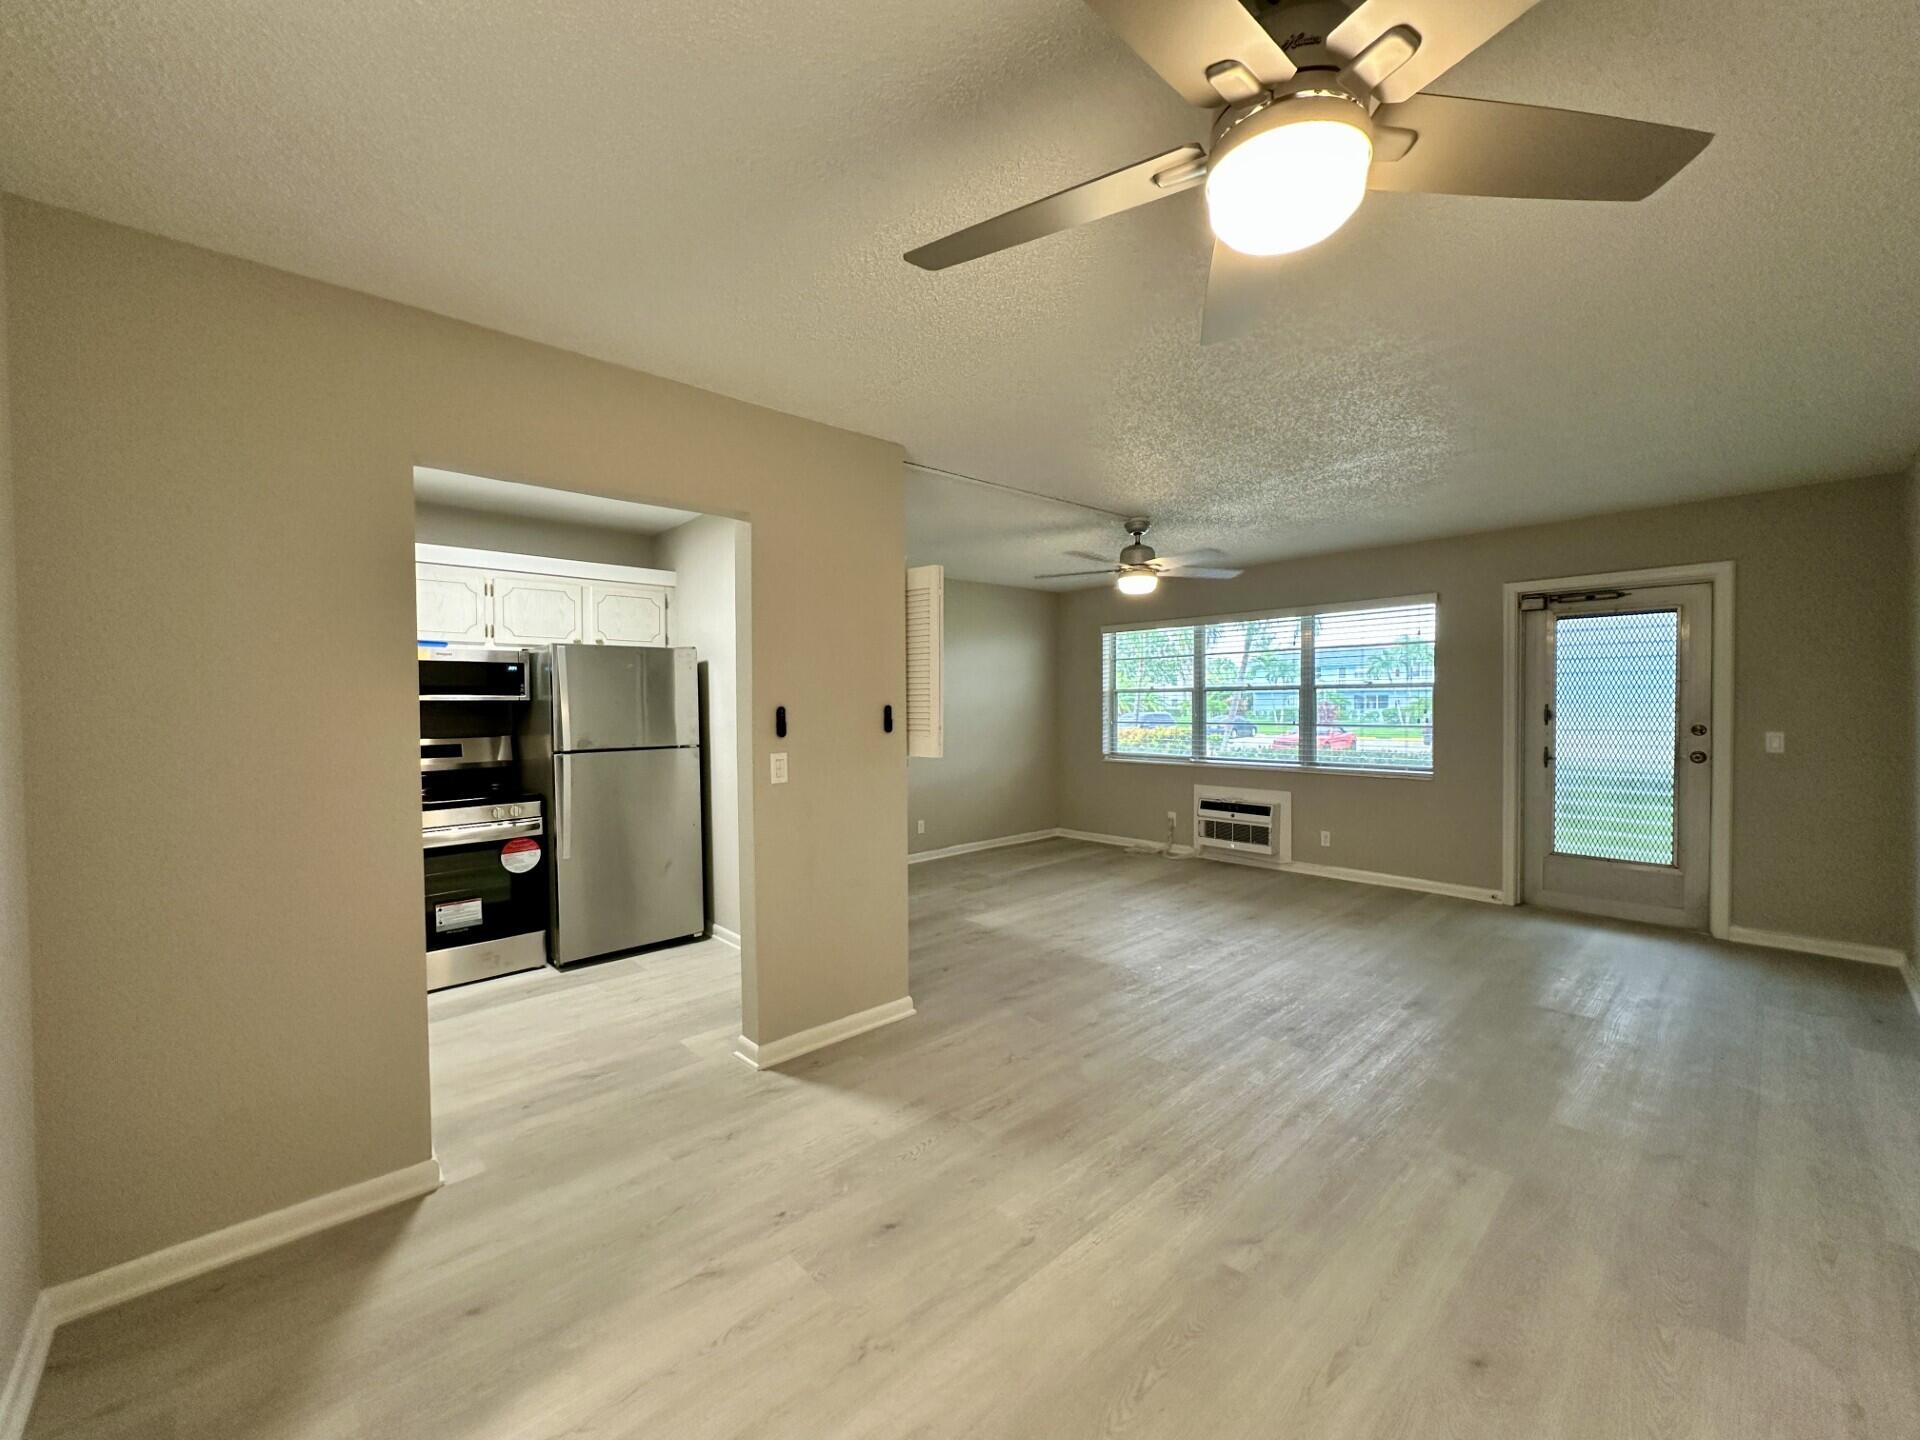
[906,0,1713,342]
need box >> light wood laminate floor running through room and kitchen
[29,841,1920,1440]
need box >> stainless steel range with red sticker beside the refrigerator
[420,735,547,991]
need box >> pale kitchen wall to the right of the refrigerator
[657,515,751,935]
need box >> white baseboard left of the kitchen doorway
[44,1160,440,1325]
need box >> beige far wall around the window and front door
[1060,476,1914,948]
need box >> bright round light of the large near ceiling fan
[1206,94,1373,255]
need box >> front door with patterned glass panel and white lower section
[1521,584,1726,929]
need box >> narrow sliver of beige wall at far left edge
[0,200,40,1384]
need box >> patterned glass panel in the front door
[1551,611,1680,866]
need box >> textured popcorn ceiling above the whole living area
[0,0,1920,582]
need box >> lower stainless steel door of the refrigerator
[553,747,707,966]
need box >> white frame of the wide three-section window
[1100,591,1440,780]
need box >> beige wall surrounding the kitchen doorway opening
[4,198,906,1281]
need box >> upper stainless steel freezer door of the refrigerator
[551,645,699,751]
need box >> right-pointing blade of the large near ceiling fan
[1367,94,1713,200]
